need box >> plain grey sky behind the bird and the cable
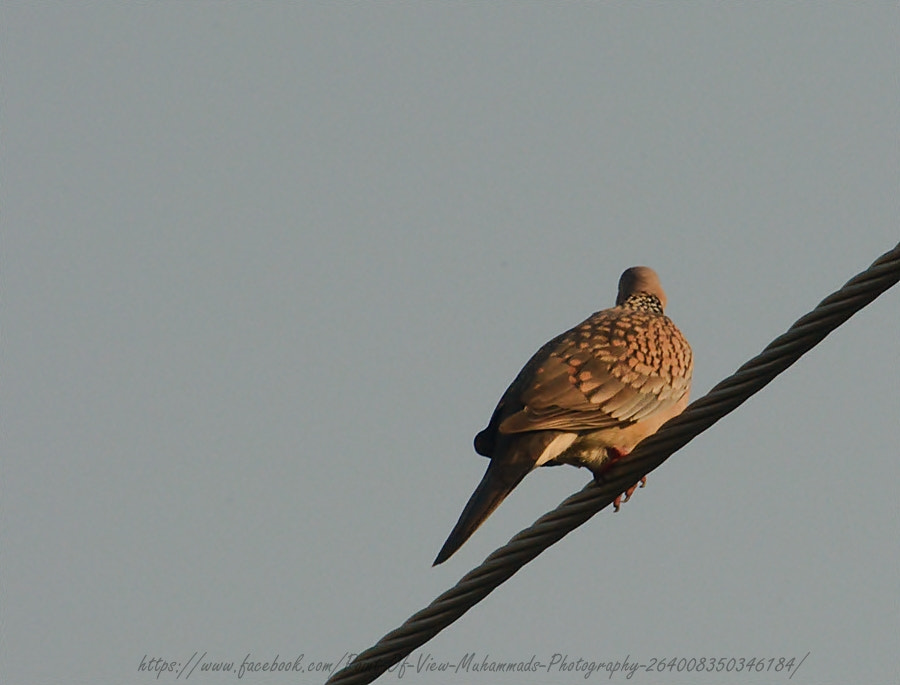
[0,2,900,685]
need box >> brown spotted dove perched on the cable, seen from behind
[433,266,694,566]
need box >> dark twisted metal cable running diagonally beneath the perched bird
[326,244,900,685]
